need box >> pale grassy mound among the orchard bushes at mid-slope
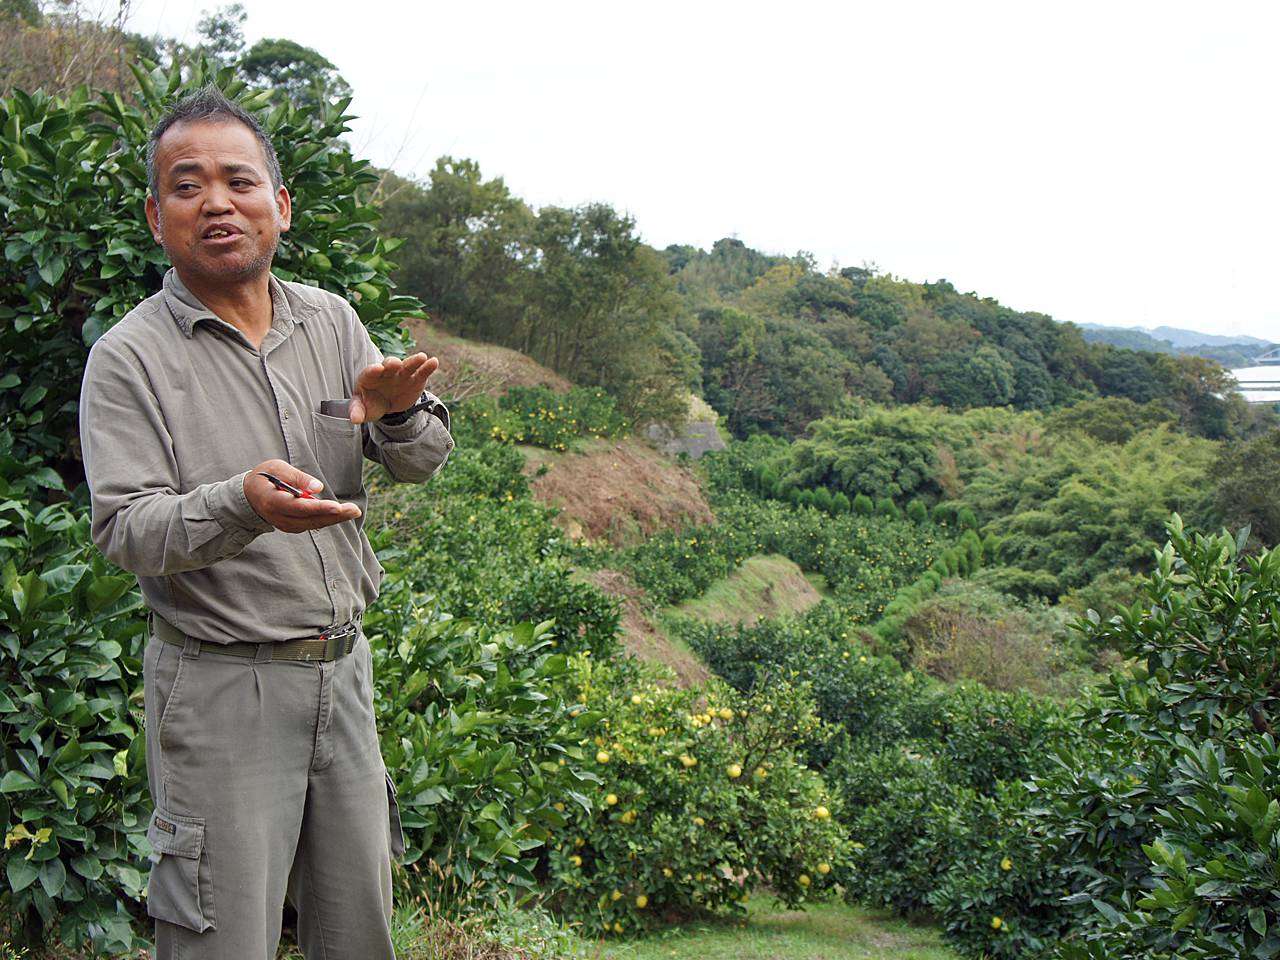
[668,553,826,623]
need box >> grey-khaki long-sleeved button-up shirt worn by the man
[79,269,453,643]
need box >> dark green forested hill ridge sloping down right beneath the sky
[379,165,1245,448]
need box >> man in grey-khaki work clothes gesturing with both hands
[79,87,453,960]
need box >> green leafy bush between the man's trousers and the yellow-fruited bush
[366,581,595,905]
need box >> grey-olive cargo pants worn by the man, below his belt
[143,619,403,960]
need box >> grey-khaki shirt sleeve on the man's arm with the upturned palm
[79,339,274,576]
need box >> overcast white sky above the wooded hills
[122,0,1280,339]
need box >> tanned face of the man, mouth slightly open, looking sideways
[147,120,291,283]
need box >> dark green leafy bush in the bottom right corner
[1039,516,1280,960]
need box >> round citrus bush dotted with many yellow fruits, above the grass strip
[550,659,849,933]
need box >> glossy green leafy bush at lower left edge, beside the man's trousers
[0,445,151,950]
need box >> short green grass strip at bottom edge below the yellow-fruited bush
[600,897,956,960]
